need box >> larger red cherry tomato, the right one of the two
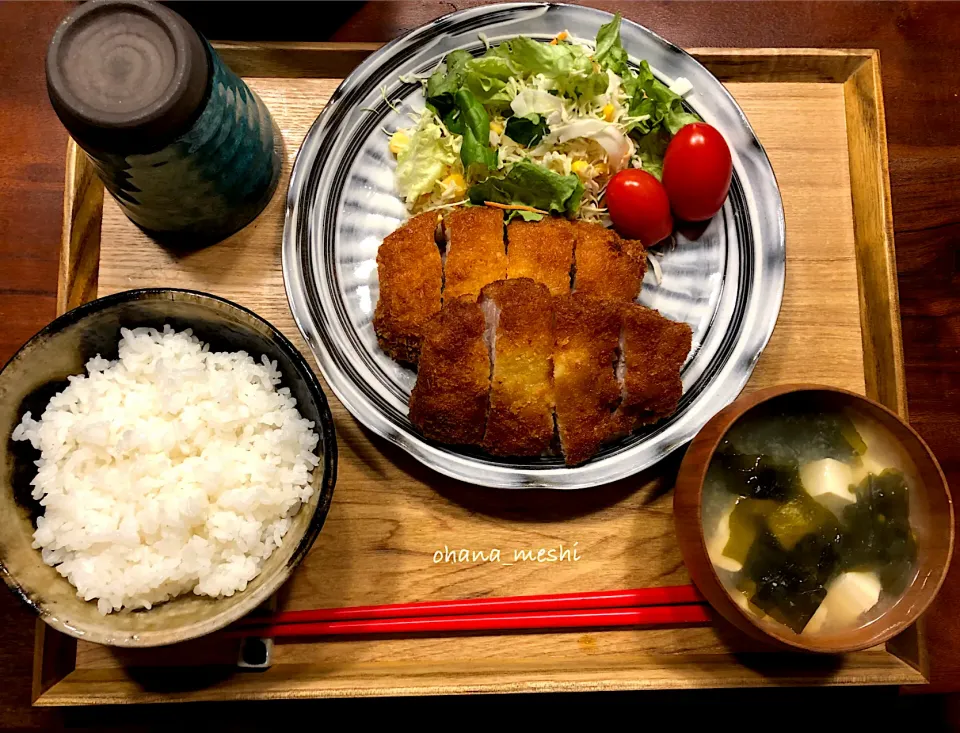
[663,122,733,221]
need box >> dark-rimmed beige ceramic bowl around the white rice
[0,288,338,648]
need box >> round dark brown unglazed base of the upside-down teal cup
[47,0,210,154]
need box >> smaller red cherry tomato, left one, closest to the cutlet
[607,168,673,247]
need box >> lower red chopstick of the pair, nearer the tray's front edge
[226,603,710,637]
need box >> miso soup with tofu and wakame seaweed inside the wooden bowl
[702,395,918,635]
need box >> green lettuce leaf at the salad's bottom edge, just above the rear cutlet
[467,160,583,215]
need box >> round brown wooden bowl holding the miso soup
[673,384,954,653]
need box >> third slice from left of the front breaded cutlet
[553,293,622,466]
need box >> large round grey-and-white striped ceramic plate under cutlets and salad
[283,4,785,489]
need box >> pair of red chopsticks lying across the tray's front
[225,585,710,638]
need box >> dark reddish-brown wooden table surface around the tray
[0,0,960,729]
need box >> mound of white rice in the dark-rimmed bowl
[13,326,319,614]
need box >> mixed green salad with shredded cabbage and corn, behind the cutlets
[390,14,699,221]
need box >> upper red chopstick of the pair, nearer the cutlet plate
[231,585,704,630]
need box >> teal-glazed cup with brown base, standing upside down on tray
[47,0,282,243]
